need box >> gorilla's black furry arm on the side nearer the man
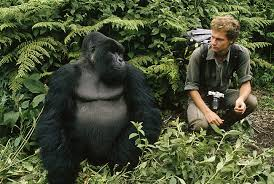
[126,65,162,144]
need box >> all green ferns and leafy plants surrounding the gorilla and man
[0,0,274,184]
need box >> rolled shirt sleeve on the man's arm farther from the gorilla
[236,47,252,85]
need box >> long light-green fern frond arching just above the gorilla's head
[64,16,145,44]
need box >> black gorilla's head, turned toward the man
[81,32,127,84]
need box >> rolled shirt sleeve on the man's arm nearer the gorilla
[184,47,201,91]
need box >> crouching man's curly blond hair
[210,15,240,42]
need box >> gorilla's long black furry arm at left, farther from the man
[37,64,79,174]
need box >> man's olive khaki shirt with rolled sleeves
[184,45,252,92]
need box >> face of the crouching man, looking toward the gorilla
[210,30,230,54]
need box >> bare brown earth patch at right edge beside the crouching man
[248,90,274,148]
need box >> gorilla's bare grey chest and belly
[75,73,128,137]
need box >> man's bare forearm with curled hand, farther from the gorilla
[234,81,251,114]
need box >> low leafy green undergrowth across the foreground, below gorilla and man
[0,118,274,184]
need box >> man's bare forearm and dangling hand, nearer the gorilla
[188,90,224,126]
